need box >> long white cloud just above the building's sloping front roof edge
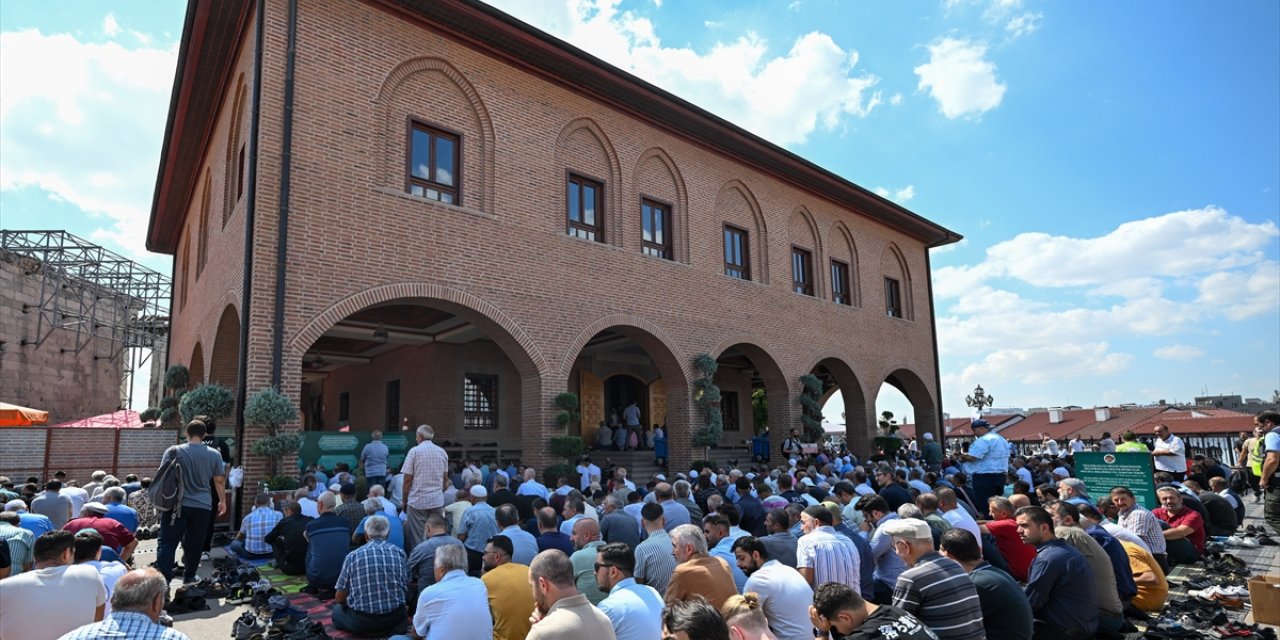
[481,0,882,145]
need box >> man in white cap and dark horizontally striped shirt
[883,518,987,640]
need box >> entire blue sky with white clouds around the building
[0,0,1280,419]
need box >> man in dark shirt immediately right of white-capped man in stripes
[938,529,1034,640]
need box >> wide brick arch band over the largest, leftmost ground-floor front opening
[289,282,549,379]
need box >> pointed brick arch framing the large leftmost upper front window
[376,56,497,214]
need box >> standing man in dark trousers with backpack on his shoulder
[150,420,227,582]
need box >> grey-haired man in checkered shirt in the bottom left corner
[59,568,189,640]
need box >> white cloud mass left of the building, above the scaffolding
[0,27,177,256]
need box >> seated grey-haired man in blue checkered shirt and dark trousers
[333,516,408,636]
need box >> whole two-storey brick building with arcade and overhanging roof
[147,0,959,475]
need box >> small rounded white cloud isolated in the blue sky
[915,37,1009,119]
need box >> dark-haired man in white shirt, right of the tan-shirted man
[733,536,813,640]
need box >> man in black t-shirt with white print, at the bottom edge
[809,582,938,640]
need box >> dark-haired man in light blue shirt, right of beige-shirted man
[595,543,665,640]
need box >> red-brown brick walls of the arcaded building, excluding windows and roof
[173,0,937,477]
